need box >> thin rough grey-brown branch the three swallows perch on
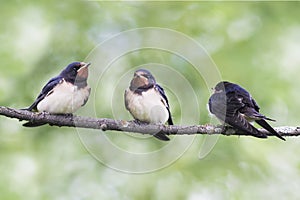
[0,106,300,136]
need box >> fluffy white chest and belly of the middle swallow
[125,88,169,124]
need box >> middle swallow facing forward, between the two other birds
[124,69,173,141]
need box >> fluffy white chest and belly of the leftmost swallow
[37,80,90,114]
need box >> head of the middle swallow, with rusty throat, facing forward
[129,69,156,91]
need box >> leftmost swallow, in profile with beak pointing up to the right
[23,62,91,127]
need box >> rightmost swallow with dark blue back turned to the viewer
[208,81,285,140]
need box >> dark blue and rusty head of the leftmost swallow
[60,62,90,84]
